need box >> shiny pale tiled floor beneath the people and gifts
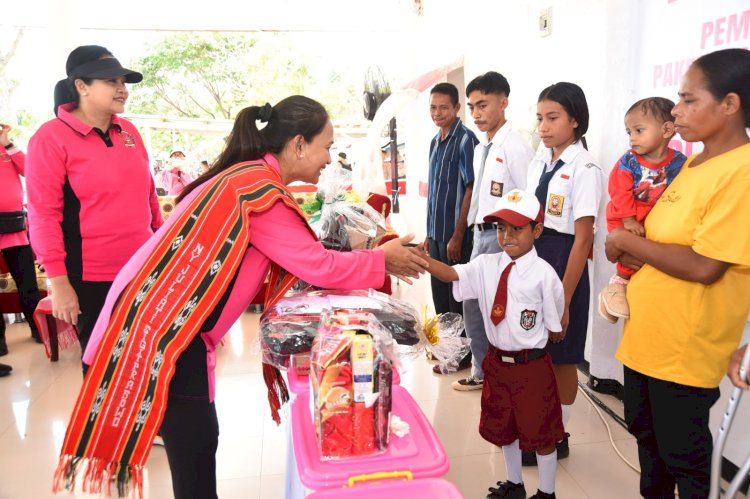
[0,300,638,499]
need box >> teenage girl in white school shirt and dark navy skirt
[524,82,604,464]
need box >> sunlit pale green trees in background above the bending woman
[127,33,362,159]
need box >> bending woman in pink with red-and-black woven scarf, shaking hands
[54,96,427,499]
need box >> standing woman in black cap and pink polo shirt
[26,45,162,372]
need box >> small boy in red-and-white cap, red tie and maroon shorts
[425,190,565,499]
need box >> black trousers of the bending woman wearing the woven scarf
[159,335,219,499]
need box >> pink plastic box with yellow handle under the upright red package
[291,385,450,491]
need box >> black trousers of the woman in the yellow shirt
[624,367,719,499]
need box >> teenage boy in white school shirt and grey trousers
[453,71,534,391]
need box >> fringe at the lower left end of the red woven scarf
[52,455,143,499]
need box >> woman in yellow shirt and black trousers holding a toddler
[605,49,750,498]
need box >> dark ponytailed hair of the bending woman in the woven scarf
[177,95,329,202]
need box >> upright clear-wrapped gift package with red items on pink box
[310,313,393,459]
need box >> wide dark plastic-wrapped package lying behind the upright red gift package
[260,290,424,369]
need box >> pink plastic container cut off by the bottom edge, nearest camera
[307,478,463,499]
